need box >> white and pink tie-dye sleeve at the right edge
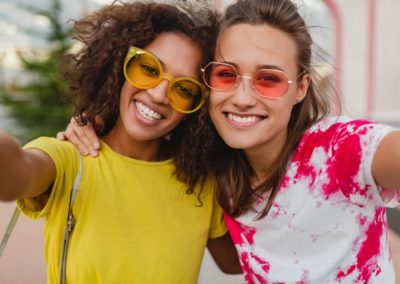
[333,120,400,207]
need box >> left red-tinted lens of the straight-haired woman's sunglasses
[203,63,237,91]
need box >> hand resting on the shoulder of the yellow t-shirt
[57,117,100,157]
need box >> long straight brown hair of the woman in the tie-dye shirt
[191,0,330,218]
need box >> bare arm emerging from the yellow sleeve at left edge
[0,132,56,201]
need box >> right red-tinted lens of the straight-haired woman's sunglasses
[253,69,289,98]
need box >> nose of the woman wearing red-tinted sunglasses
[232,76,257,108]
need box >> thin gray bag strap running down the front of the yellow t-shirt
[60,155,82,284]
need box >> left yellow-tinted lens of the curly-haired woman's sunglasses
[125,52,162,89]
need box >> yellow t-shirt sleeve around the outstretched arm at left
[17,137,79,219]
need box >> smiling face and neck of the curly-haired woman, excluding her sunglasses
[105,33,201,159]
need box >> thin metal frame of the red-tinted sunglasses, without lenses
[201,61,296,99]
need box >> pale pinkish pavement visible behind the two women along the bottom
[0,203,400,284]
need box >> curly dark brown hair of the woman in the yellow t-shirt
[64,1,218,197]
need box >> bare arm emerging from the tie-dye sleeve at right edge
[372,131,400,189]
